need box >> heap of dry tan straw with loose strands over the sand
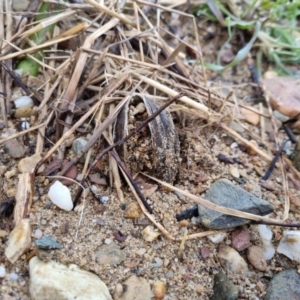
[0,0,296,241]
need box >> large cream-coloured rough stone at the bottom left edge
[29,256,112,300]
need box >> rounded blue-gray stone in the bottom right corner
[265,269,300,300]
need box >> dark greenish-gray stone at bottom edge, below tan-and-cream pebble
[209,272,239,300]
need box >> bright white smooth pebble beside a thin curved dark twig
[48,181,73,211]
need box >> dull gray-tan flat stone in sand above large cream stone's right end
[96,243,124,265]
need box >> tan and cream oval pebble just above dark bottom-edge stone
[217,244,248,274]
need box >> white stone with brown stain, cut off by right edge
[277,230,300,263]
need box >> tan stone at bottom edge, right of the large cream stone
[119,275,152,300]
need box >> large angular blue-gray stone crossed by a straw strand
[198,179,274,229]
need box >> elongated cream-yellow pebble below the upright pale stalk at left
[5,219,31,264]
